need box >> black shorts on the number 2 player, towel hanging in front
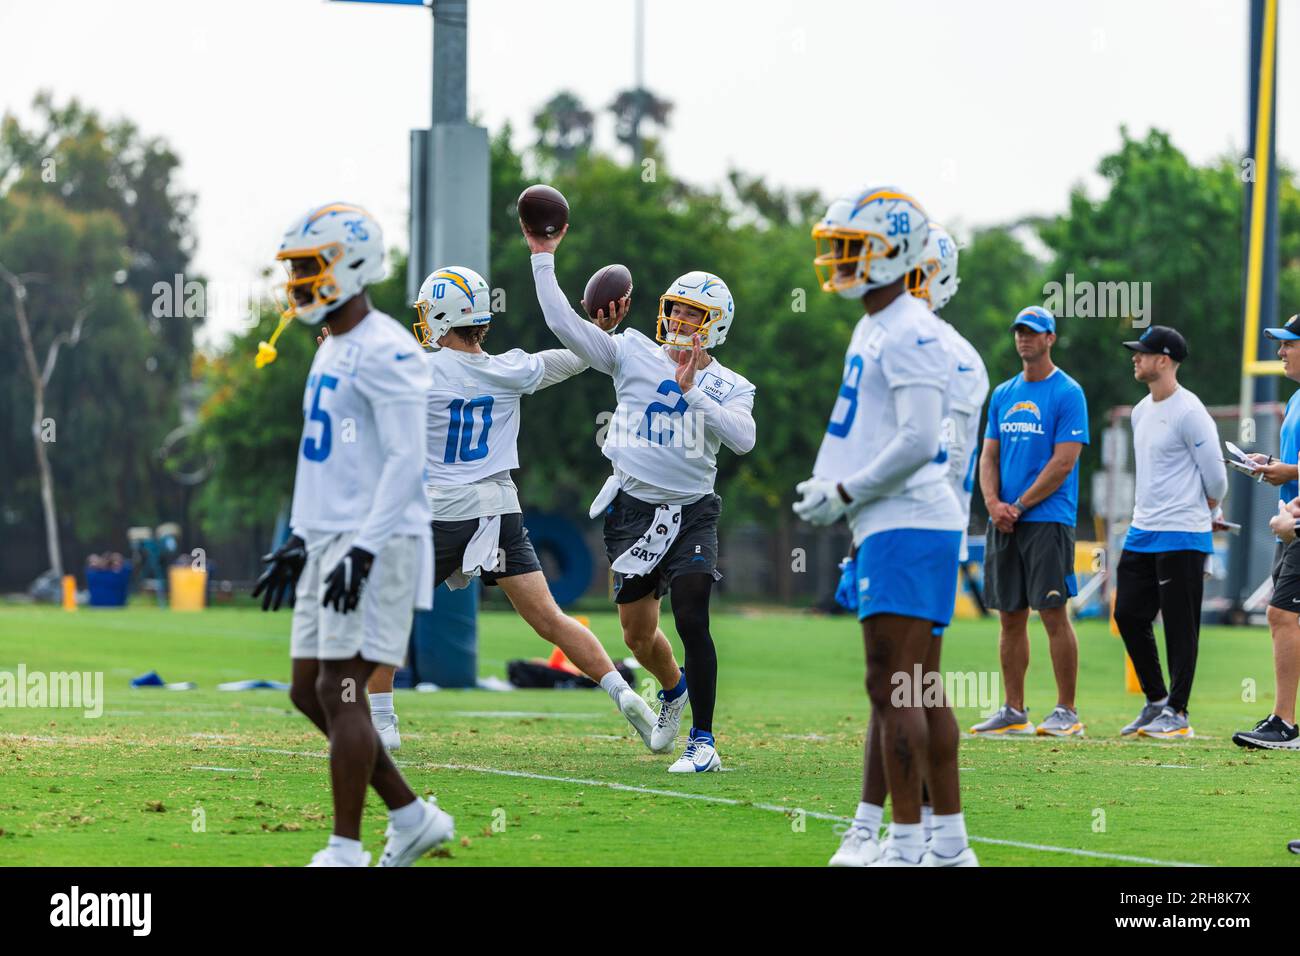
[605,492,723,604]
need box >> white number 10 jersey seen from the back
[425,349,586,522]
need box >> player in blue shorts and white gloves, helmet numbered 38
[794,186,975,866]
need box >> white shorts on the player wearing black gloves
[289,531,423,667]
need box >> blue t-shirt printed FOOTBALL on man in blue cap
[984,368,1088,528]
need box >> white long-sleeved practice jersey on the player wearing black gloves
[291,310,429,553]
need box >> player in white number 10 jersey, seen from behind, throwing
[390,265,655,747]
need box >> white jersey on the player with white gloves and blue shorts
[813,295,966,544]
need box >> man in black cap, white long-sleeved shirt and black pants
[1115,325,1227,740]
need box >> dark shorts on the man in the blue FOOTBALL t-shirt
[984,522,1078,611]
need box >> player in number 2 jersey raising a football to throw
[524,226,755,774]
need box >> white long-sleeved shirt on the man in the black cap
[1132,388,1227,532]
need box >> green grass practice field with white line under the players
[0,606,1300,866]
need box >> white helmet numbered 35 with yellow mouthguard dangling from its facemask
[276,203,384,324]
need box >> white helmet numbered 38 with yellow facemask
[813,186,930,298]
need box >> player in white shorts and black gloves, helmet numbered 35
[254,203,454,866]
